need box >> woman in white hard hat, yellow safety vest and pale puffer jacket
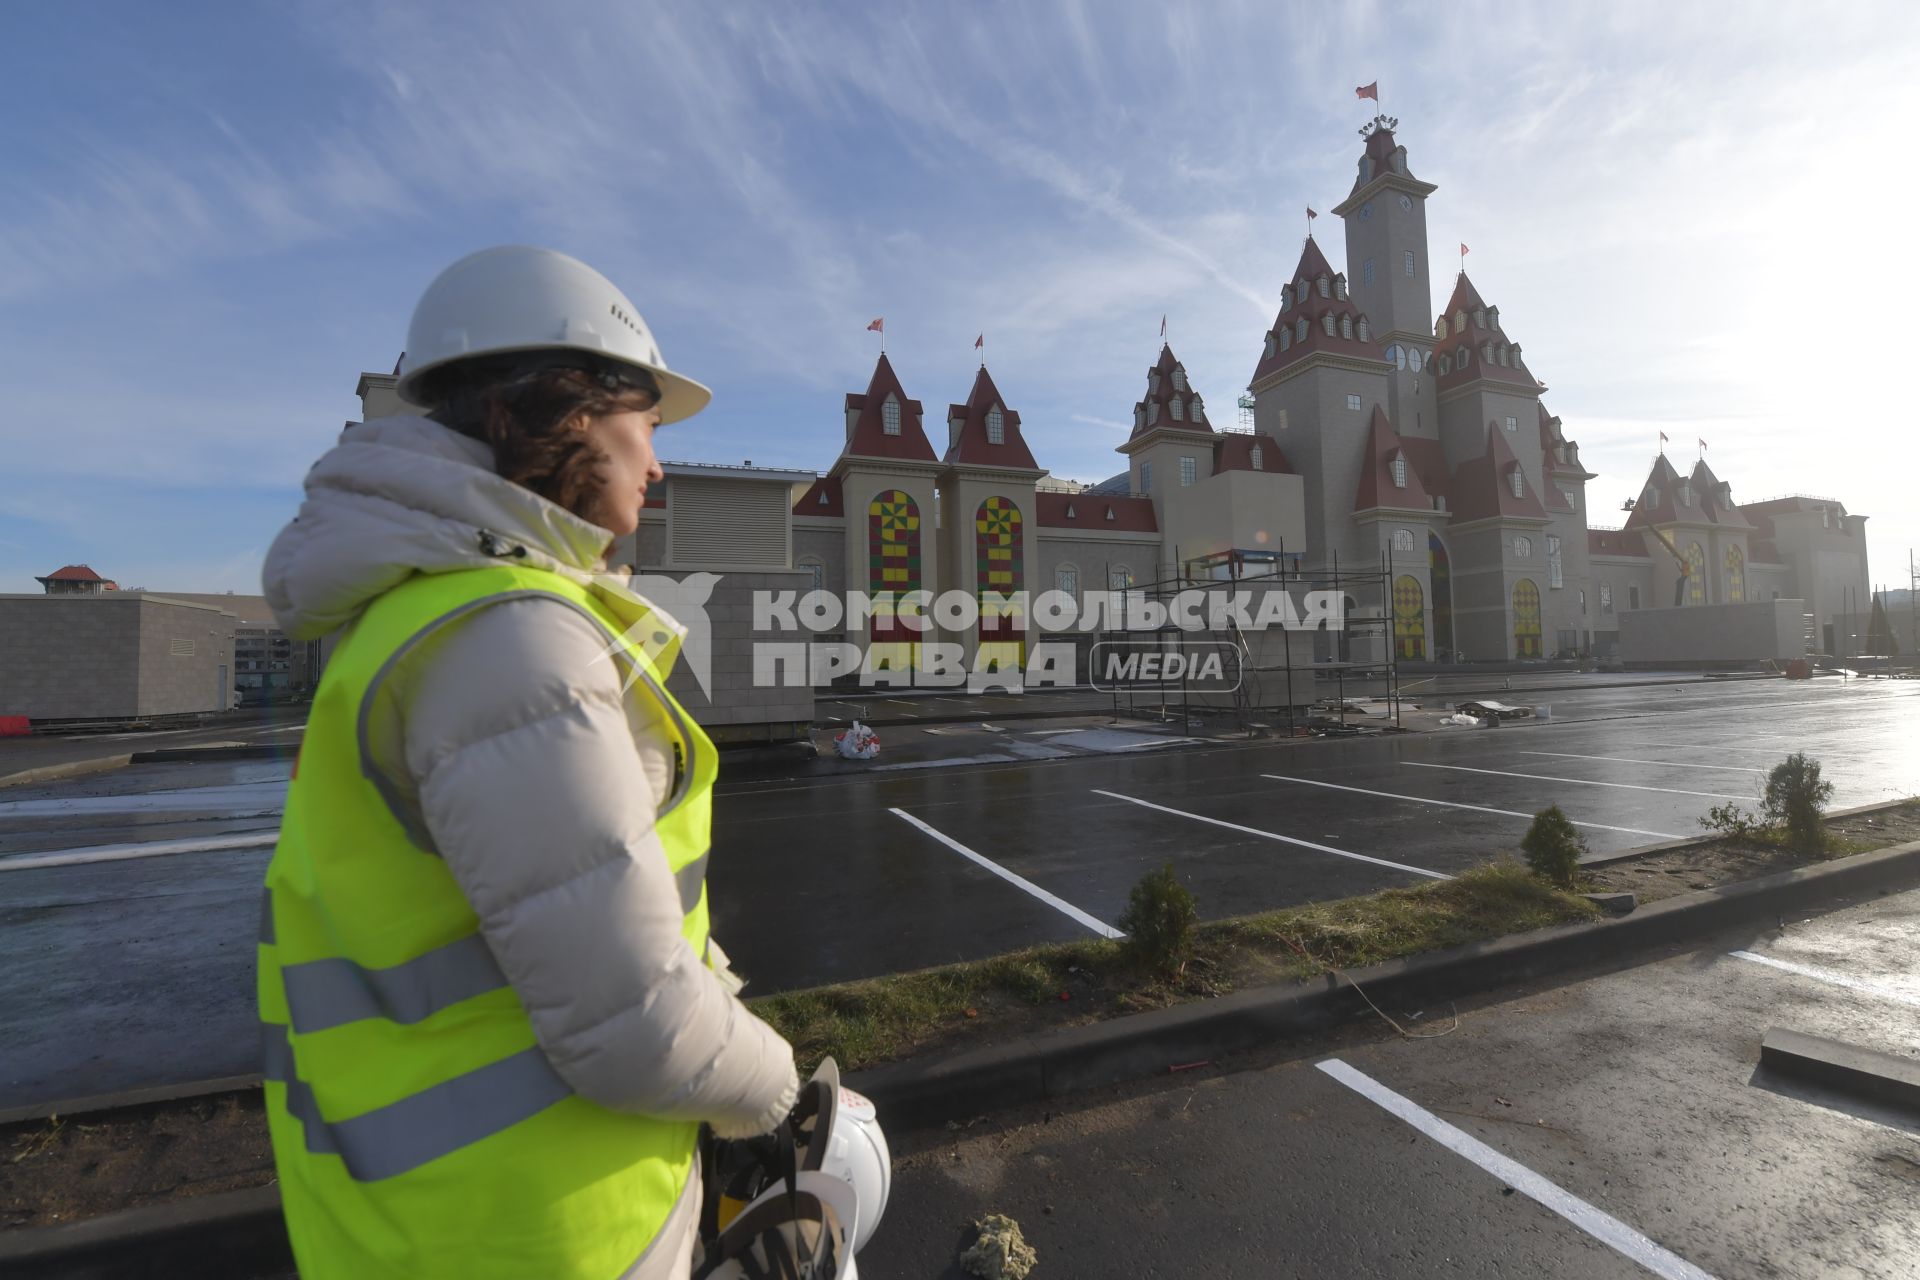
[259,248,799,1280]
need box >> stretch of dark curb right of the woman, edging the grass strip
[847,841,1920,1128]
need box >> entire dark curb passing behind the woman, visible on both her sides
[0,841,1920,1280]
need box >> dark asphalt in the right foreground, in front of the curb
[860,892,1920,1280]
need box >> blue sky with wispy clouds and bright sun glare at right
[0,0,1920,593]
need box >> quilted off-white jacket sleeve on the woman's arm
[394,599,799,1136]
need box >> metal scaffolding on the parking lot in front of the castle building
[1089,549,1402,737]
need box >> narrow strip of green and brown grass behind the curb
[749,858,1597,1075]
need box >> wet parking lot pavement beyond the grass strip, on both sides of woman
[0,681,1920,1107]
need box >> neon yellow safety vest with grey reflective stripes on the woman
[259,566,716,1280]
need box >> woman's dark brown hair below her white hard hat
[420,359,659,524]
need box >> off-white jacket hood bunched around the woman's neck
[261,416,614,641]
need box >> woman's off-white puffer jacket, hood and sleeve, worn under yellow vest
[265,416,799,1136]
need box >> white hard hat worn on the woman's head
[399,244,712,422]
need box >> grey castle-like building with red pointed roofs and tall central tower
[791,117,1868,662]
